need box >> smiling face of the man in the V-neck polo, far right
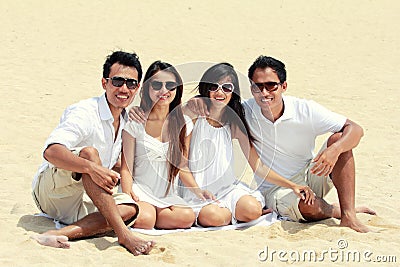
[252,68,287,120]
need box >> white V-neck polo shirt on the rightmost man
[243,95,346,190]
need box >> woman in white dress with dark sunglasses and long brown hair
[121,61,211,229]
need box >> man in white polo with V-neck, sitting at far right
[244,56,375,232]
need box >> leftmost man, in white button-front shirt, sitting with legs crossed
[32,51,154,255]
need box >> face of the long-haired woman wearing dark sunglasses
[149,71,176,107]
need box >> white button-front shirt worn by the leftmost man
[32,94,128,191]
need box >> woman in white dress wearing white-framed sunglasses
[183,63,314,227]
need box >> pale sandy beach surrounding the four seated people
[0,0,400,266]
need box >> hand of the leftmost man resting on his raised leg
[88,163,121,194]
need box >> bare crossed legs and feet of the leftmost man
[32,147,154,255]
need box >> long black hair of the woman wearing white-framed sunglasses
[198,62,255,146]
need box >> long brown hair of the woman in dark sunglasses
[140,60,186,195]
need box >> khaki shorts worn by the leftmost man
[32,148,139,226]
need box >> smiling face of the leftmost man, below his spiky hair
[101,63,139,115]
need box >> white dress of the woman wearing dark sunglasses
[124,118,192,208]
